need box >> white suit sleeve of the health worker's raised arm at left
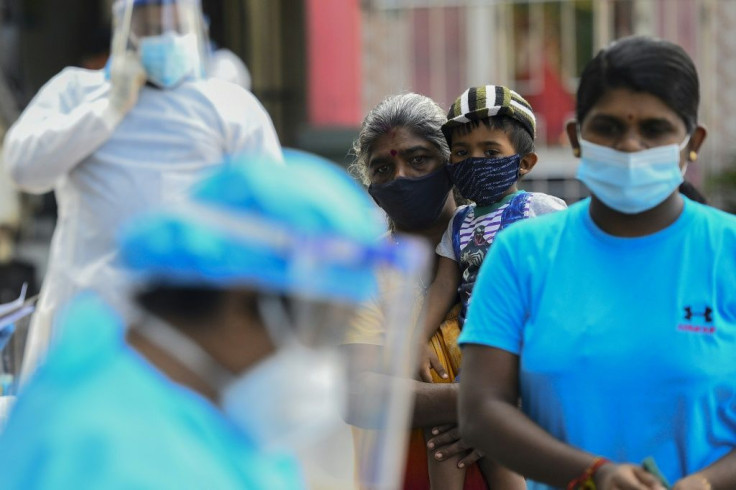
[3,69,122,193]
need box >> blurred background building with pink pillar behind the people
[0,0,736,290]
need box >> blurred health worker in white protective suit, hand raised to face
[4,0,282,378]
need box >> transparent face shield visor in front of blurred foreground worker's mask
[282,235,431,489]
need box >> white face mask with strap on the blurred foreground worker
[138,310,347,452]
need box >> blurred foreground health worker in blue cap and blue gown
[0,154,424,490]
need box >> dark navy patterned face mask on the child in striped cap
[447,155,521,206]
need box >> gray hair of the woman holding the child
[350,92,450,185]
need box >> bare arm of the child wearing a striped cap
[422,257,460,341]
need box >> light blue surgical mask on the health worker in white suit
[140,31,199,88]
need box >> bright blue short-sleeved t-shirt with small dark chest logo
[459,199,736,489]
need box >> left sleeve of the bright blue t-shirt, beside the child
[458,229,528,354]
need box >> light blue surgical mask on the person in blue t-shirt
[577,137,690,214]
